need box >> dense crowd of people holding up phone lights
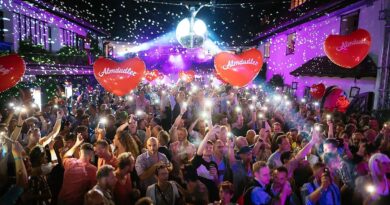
[0,83,390,205]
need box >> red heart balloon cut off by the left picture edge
[0,54,26,92]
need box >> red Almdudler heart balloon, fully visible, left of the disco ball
[93,58,146,96]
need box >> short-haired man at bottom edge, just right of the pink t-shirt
[84,165,117,205]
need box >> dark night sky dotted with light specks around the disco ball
[30,0,290,47]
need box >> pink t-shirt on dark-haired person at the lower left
[59,158,97,205]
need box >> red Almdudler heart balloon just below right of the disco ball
[214,48,263,87]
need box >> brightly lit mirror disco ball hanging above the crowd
[176,18,207,48]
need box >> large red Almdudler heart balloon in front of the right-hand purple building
[324,29,371,68]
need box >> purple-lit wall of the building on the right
[259,0,384,97]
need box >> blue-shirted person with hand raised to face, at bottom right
[301,162,341,205]
